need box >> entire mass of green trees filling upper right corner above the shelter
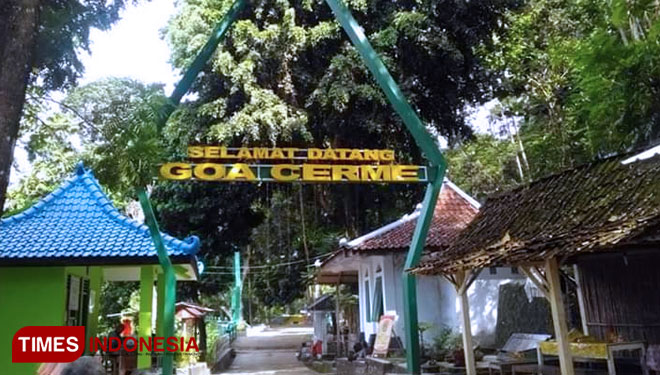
[481,0,660,177]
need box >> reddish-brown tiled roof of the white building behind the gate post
[344,180,479,252]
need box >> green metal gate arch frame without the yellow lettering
[138,0,447,375]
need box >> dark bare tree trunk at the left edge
[0,0,39,213]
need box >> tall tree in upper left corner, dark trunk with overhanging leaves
[0,0,138,212]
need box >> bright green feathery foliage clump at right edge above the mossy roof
[567,12,660,155]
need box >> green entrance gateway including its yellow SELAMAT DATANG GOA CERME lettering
[138,0,452,375]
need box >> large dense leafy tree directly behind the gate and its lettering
[155,0,515,304]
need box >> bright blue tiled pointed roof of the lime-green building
[0,163,200,265]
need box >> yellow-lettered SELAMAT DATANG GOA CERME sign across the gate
[160,146,430,183]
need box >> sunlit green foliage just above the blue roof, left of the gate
[7,78,165,214]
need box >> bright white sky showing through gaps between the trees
[10,0,492,187]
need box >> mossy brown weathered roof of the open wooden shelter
[414,151,660,274]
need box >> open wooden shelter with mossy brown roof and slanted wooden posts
[412,152,660,375]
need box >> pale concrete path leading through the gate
[219,327,318,375]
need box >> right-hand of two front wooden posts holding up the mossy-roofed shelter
[545,258,575,375]
